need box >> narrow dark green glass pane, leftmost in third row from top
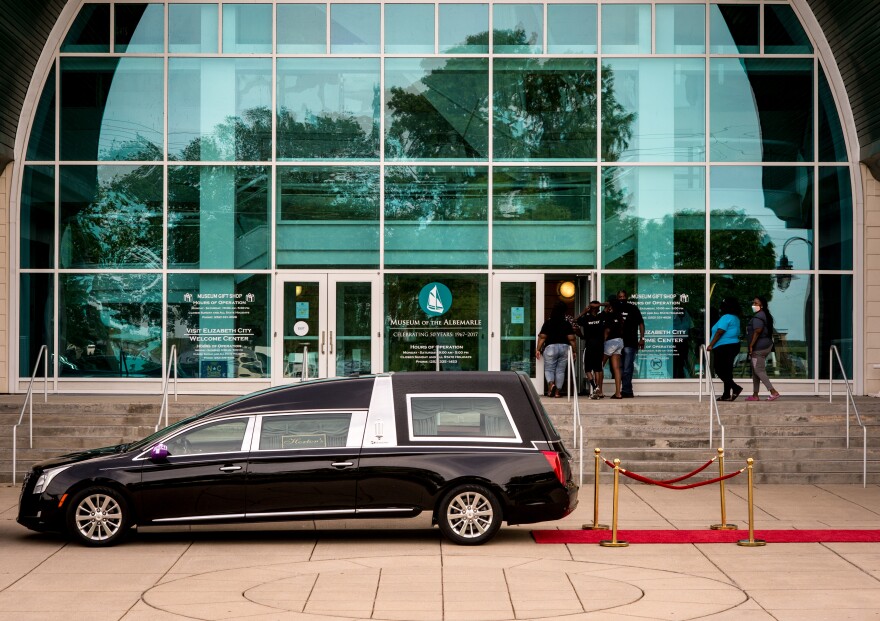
[20,166,55,269]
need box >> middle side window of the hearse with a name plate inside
[260,413,351,451]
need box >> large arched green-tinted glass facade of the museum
[14,0,859,383]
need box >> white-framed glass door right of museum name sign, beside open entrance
[489,274,544,391]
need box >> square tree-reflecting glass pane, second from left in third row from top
[58,166,163,268]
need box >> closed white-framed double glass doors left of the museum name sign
[273,274,381,384]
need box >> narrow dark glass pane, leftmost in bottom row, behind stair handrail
[18,274,55,377]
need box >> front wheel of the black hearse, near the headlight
[67,487,131,547]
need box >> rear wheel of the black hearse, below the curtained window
[437,485,502,546]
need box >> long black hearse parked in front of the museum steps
[18,372,578,546]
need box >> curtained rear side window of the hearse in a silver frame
[407,394,519,440]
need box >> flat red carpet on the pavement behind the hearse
[532,529,880,543]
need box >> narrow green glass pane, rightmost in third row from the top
[817,166,853,270]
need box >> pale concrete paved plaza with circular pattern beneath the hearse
[0,485,880,621]
